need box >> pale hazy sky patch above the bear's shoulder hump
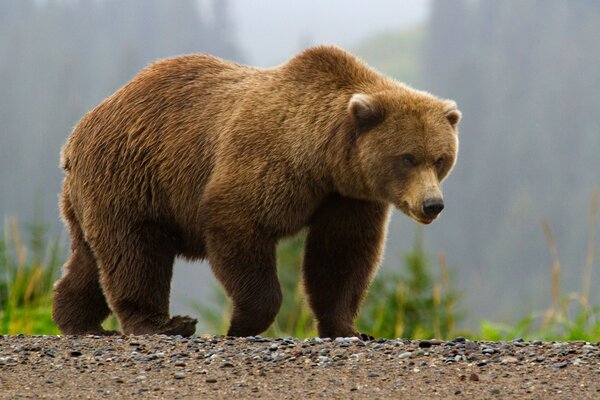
[214,0,429,66]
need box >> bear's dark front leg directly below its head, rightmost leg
[303,195,390,338]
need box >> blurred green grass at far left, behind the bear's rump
[0,218,64,334]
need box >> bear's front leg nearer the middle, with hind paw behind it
[206,225,282,336]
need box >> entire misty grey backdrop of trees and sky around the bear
[0,0,600,326]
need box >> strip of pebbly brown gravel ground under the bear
[0,335,600,399]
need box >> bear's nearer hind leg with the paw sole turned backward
[93,223,197,336]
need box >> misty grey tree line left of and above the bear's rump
[0,0,241,226]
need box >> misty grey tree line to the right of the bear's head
[423,0,600,322]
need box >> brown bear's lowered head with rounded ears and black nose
[347,87,461,224]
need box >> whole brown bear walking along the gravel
[53,46,461,337]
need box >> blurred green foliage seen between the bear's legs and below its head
[192,231,461,338]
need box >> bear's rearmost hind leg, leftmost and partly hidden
[52,196,115,335]
